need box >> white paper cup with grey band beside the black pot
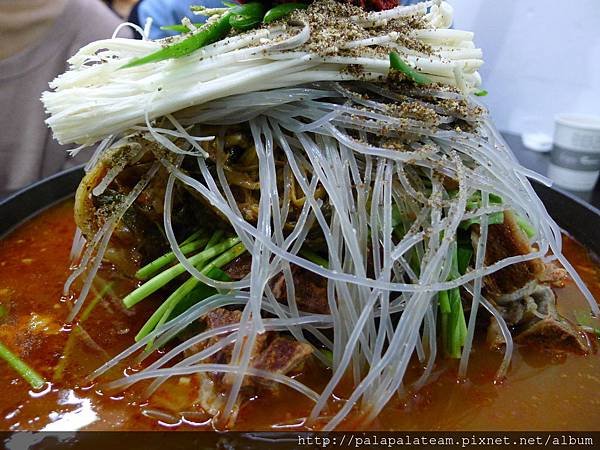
[548,114,600,191]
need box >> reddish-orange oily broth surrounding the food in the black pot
[0,201,600,430]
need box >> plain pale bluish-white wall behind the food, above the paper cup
[450,0,600,135]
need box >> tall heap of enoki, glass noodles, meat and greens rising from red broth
[43,0,598,430]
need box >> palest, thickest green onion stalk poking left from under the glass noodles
[123,237,240,308]
